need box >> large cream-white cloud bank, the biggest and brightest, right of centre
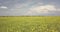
[25,5,56,15]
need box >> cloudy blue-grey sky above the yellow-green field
[0,0,60,16]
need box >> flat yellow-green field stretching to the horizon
[0,16,60,32]
